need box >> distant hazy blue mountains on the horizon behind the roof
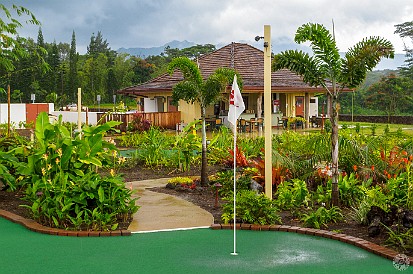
[117,39,406,70]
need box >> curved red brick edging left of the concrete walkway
[0,209,132,237]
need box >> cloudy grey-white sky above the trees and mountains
[2,0,413,53]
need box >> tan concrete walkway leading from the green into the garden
[126,178,214,232]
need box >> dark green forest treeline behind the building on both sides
[0,24,413,115]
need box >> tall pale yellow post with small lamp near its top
[264,25,272,199]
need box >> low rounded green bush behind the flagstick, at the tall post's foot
[222,190,281,225]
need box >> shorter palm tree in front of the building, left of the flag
[168,57,242,185]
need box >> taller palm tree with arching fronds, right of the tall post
[272,23,394,206]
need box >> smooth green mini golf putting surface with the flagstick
[0,218,406,273]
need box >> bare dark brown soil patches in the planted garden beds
[0,163,406,255]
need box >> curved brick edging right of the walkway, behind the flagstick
[210,224,413,265]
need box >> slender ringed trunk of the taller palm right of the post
[330,93,339,206]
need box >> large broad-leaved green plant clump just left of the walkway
[25,112,138,230]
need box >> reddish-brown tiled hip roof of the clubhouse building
[118,43,324,95]
